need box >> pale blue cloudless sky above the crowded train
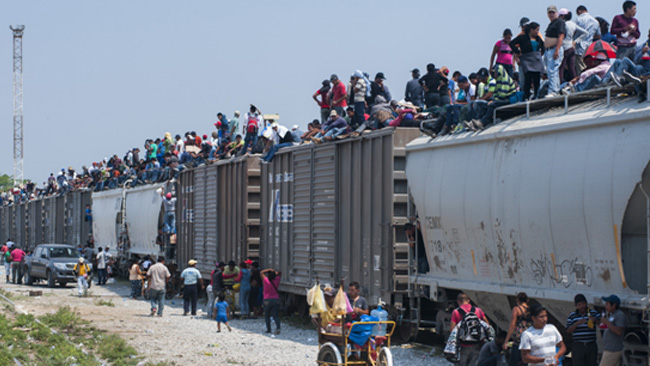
[0,0,650,184]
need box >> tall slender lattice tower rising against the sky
[9,25,25,187]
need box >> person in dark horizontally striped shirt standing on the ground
[566,294,600,366]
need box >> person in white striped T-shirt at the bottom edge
[519,305,566,366]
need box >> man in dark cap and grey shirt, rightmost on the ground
[600,294,625,366]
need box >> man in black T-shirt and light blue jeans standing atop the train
[544,5,566,97]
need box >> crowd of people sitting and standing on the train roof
[0,0,650,205]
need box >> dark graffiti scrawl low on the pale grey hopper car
[530,254,593,288]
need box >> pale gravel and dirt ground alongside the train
[0,275,449,366]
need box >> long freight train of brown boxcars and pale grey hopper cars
[5,90,650,365]
